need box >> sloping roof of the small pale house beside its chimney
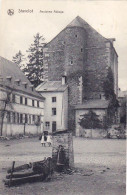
[36,81,67,92]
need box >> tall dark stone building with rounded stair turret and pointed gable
[43,16,118,134]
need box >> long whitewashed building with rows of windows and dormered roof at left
[0,57,45,136]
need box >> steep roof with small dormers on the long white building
[0,56,44,100]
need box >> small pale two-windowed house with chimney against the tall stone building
[36,77,68,133]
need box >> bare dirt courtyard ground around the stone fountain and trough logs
[0,138,126,195]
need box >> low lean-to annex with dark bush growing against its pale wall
[75,99,109,138]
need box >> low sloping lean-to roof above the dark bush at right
[75,99,109,110]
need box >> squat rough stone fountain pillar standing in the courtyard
[52,132,74,167]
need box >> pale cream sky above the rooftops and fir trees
[0,0,127,90]
